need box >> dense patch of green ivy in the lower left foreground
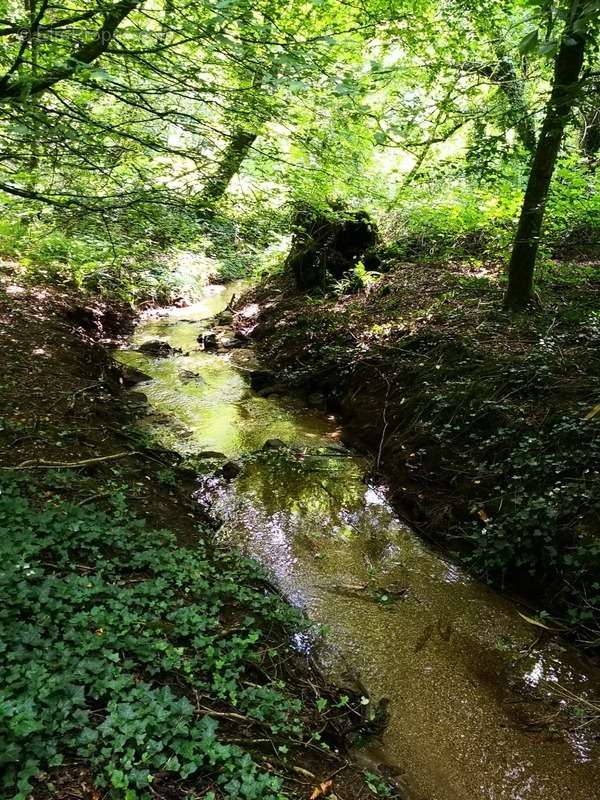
[0,471,366,800]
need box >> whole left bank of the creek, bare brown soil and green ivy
[0,264,388,800]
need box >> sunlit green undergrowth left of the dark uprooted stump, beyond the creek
[0,200,285,307]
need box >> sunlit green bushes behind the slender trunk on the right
[383,153,600,260]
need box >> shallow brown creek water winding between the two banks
[118,285,600,800]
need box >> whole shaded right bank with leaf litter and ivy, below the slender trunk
[233,262,600,652]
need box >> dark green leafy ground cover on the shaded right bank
[422,328,600,647]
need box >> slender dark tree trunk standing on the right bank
[504,22,585,310]
